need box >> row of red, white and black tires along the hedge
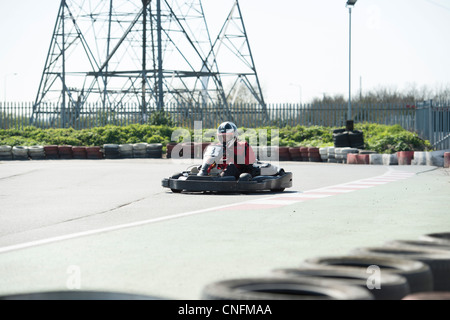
[0,143,450,168]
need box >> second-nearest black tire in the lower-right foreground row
[275,267,410,300]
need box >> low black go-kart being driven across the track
[161,145,292,193]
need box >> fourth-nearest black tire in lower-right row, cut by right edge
[354,247,450,291]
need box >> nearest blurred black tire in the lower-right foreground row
[202,277,373,300]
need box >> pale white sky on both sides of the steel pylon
[0,0,450,103]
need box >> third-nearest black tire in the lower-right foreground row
[303,254,433,293]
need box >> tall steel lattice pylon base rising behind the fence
[32,0,265,124]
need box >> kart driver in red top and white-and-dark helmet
[200,121,256,179]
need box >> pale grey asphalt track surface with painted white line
[0,159,450,300]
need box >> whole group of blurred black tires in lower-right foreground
[201,232,450,300]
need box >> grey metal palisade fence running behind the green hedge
[0,101,450,149]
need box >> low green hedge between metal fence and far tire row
[0,124,432,153]
